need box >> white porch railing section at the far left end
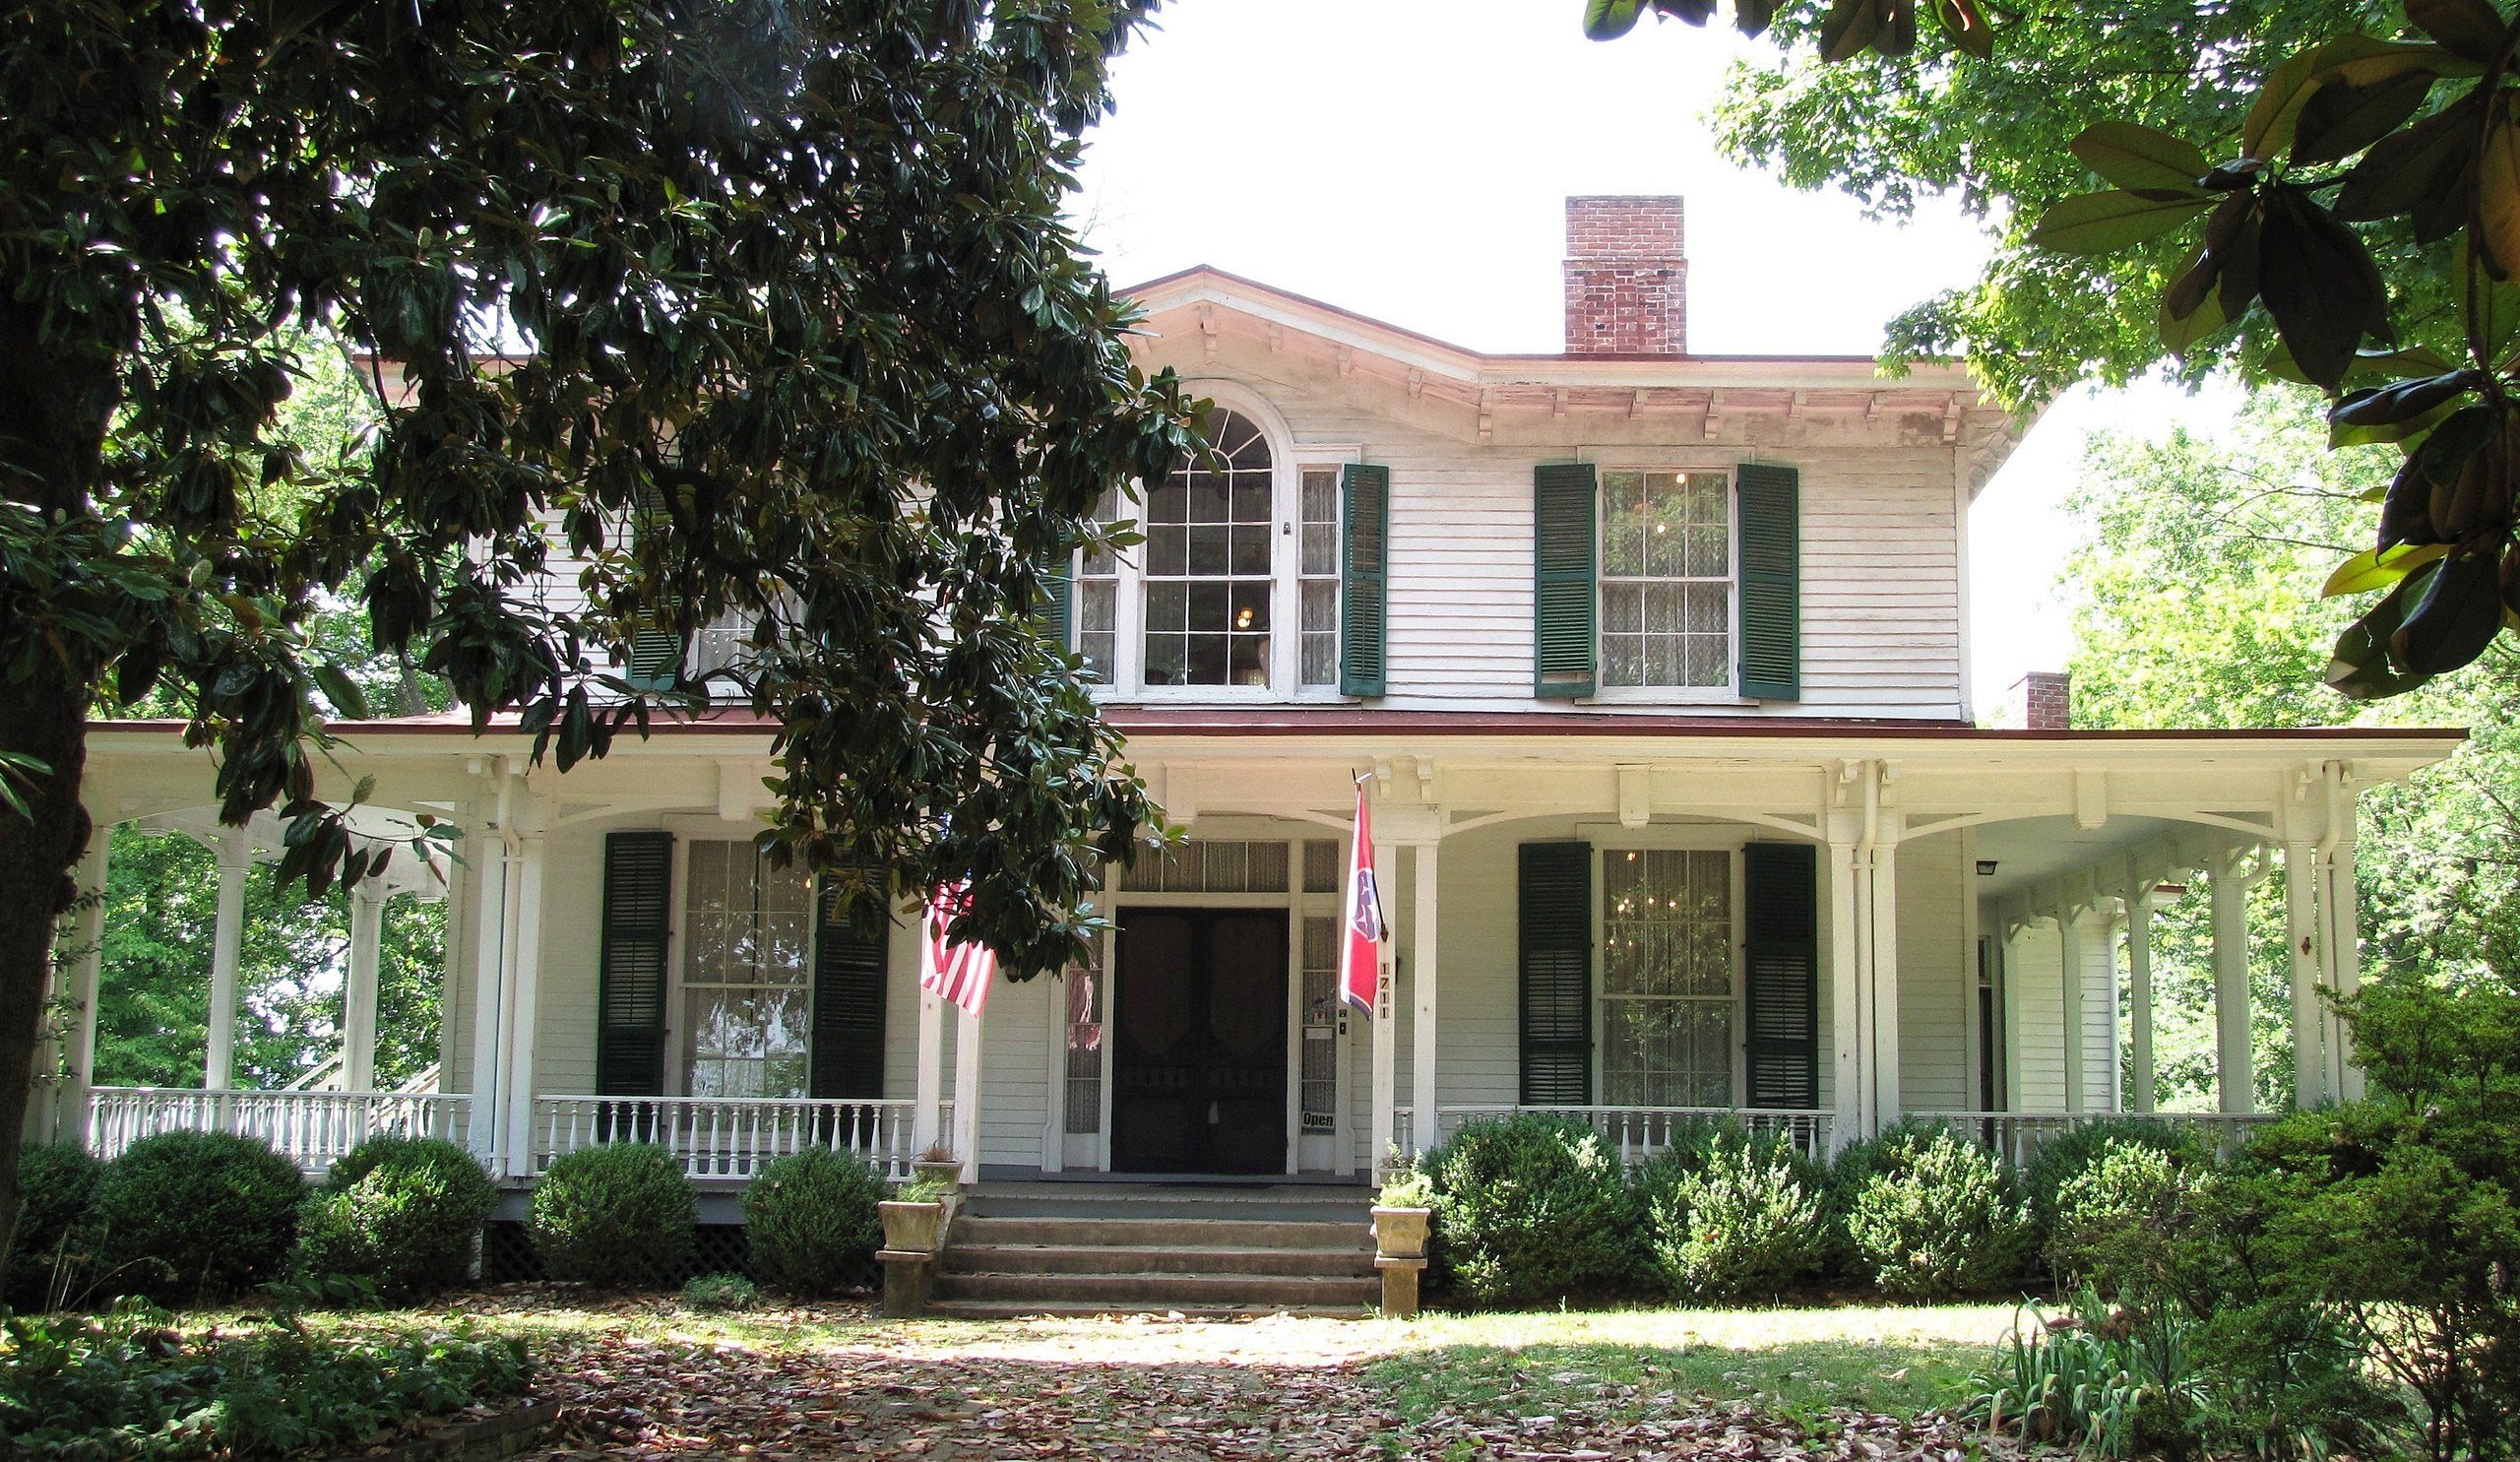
[89,1087,472,1170]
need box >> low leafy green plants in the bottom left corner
[0,1301,530,1462]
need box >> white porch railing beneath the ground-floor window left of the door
[535,1097,953,1179]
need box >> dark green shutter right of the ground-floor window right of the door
[1741,842,1819,1110]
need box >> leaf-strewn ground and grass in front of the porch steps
[408,1293,2011,1462]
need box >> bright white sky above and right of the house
[1076,0,2237,714]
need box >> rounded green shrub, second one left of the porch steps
[524,1142,701,1288]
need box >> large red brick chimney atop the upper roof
[1567,197,1688,355]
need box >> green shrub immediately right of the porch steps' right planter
[1423,1114,1635,1305]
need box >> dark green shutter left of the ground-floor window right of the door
[1520,842,1593,1107]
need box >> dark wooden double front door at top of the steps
[1111,908,1286,1173]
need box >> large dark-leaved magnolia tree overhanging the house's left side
[0,0,1197,1240]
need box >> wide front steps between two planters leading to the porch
[935,1182,1381,1318]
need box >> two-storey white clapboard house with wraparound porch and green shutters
[37,197,2457,1184]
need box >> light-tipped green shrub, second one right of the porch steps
[1641,1132,1830,1303]
